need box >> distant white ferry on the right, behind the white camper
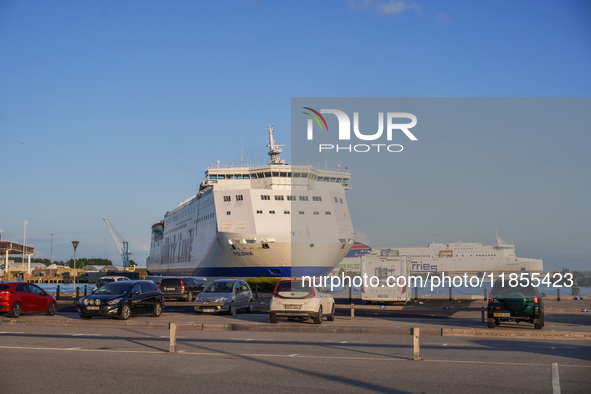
[387,234,544,274]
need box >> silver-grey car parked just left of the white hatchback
[195,279,254,313]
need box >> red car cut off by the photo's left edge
[0,282,57,317]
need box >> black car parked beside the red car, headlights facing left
[78,280,164,320]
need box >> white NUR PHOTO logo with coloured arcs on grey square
[302,107,418,153]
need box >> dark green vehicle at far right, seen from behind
[487,279,544,330]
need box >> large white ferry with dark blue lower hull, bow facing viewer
[146,125,354,277]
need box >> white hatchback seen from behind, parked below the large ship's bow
[269,279,335,324]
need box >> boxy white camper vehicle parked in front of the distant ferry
[361,249,412,304]
